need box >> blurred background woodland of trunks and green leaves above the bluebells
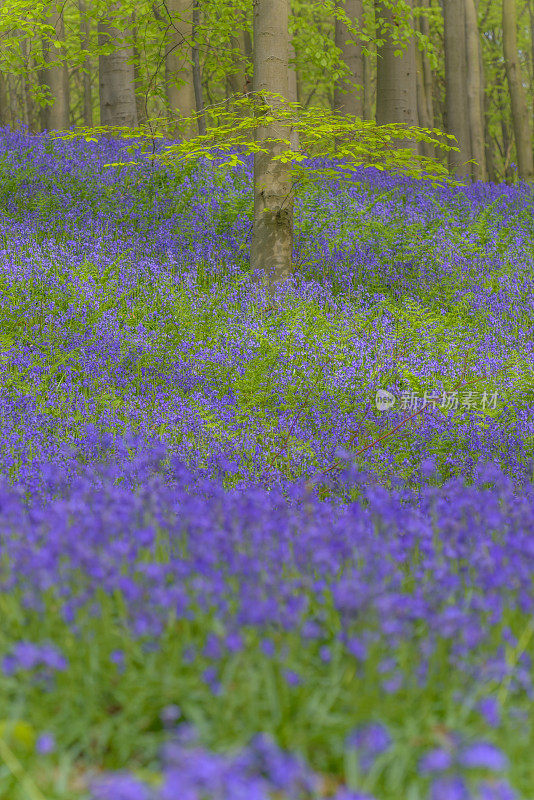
[0,0,534,182]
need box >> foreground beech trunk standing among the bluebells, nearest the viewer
[250,0,293,294]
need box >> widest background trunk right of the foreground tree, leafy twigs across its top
[375,0,419,153]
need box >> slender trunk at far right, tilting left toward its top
[502,0,534,181]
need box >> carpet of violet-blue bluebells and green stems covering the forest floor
[0,130,534,800]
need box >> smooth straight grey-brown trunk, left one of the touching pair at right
[443,0,471,179]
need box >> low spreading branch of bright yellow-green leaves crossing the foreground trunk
[52,92,456,197]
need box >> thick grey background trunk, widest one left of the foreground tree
[98,6,137,128]
